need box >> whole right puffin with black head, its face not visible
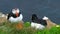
[31,14,47,30]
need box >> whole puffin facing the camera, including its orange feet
[7,8,23,29]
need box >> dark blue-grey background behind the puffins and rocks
[0,0,60,24]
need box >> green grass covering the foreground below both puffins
[0,22,60,34]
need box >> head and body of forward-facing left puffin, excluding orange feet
[7,8,23,22]
